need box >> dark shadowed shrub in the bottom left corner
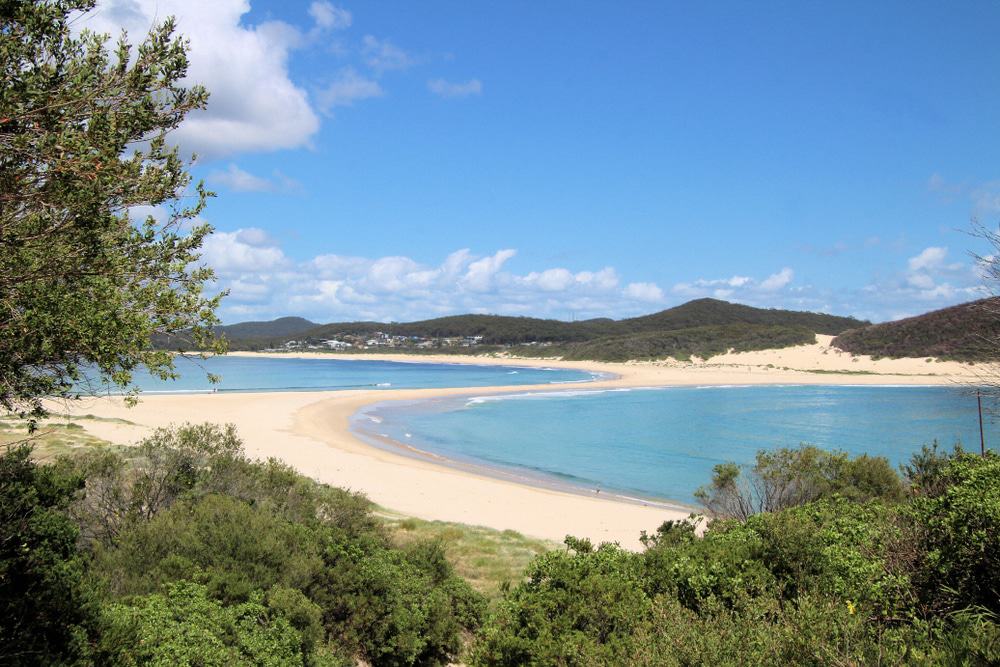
[0,446,93,665]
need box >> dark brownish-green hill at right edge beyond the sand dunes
[833,297,1000,361]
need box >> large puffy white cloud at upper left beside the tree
[82,0,319,157]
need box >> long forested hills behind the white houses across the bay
[199,299,867,360]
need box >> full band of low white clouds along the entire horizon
[193,228,985,322]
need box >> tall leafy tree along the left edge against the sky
[0,0,222,428]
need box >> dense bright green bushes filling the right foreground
[472,449,1000,665]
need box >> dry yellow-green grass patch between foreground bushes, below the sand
[377,509,559,600]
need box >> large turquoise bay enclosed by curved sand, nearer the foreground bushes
[354,386,1000,503]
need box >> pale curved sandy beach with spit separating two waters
[54,336,982,548]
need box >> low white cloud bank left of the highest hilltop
[203,239,664,321]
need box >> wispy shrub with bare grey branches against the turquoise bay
[695,445,903,521]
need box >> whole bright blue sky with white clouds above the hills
[75,0,1000,323]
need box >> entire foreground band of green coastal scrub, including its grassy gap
[0,424,1000,665]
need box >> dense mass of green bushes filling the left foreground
[0,425,485,665]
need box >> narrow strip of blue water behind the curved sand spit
[88,356,596,393]
